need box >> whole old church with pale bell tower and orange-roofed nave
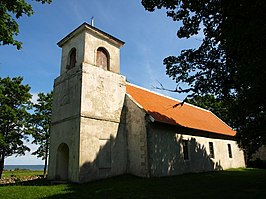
[48,23,245,183]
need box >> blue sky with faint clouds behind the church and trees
[0,0,200,164]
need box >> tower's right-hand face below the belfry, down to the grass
[79,63,127,182]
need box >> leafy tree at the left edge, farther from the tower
[0,77,31,179]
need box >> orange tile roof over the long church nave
[126,83,236,136]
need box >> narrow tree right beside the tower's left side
[30,92,53,175]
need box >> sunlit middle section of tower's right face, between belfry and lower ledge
[81,63,126,122]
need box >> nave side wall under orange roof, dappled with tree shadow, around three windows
[148,124,245,176]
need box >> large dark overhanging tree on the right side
[142,0,266,159]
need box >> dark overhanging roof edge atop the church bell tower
[57,22,125,47]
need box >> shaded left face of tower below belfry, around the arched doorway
[48,68,81,182]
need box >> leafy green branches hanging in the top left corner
[0,0,52,49]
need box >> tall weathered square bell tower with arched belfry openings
[48,23,127,183]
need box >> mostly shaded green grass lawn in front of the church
[0,169,266,199]
